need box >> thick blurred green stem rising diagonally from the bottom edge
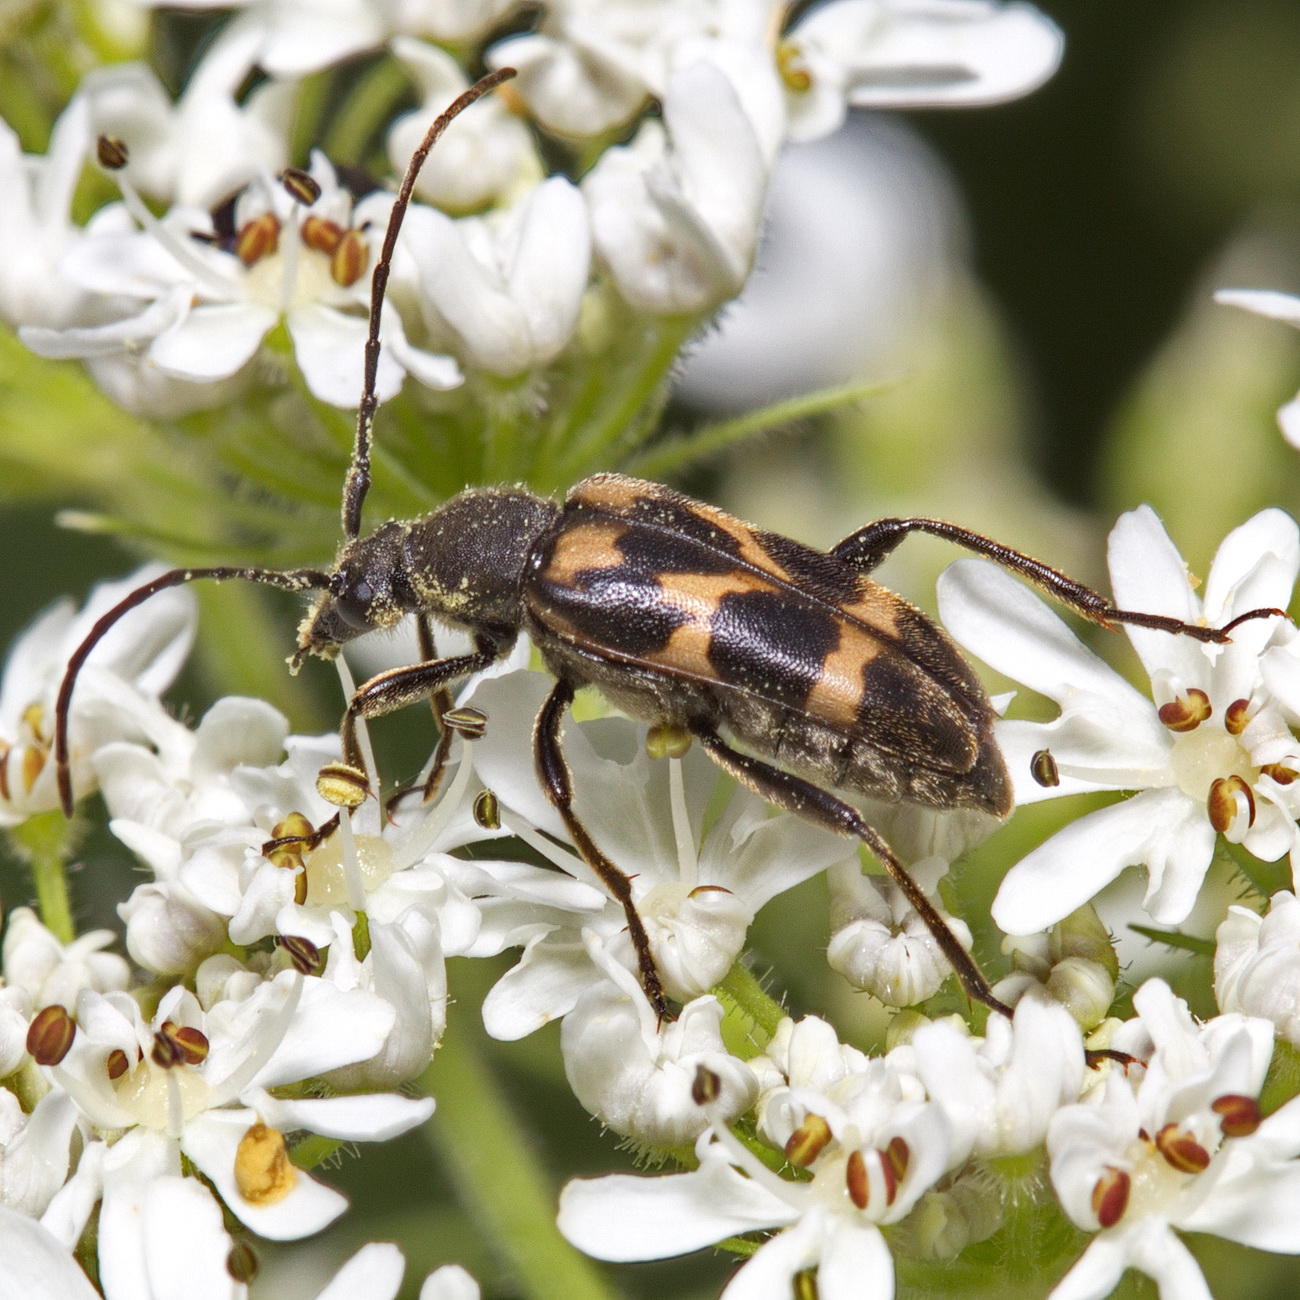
[421,963,615,1300]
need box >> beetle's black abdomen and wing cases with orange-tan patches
[525,475,1009,811]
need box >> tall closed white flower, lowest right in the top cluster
[582,61,767,315]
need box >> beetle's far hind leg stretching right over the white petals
[831,519,1287,645]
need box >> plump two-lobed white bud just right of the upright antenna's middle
[404,177,592,374]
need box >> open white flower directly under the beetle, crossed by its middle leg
[469,672,855,1039]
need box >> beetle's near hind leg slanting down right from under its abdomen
[688,722,1013,1017]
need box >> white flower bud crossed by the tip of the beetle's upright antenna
[389,36,545,215]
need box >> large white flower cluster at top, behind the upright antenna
[0,0,1061,417]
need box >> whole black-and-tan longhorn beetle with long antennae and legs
[55,69,1281,1018]
